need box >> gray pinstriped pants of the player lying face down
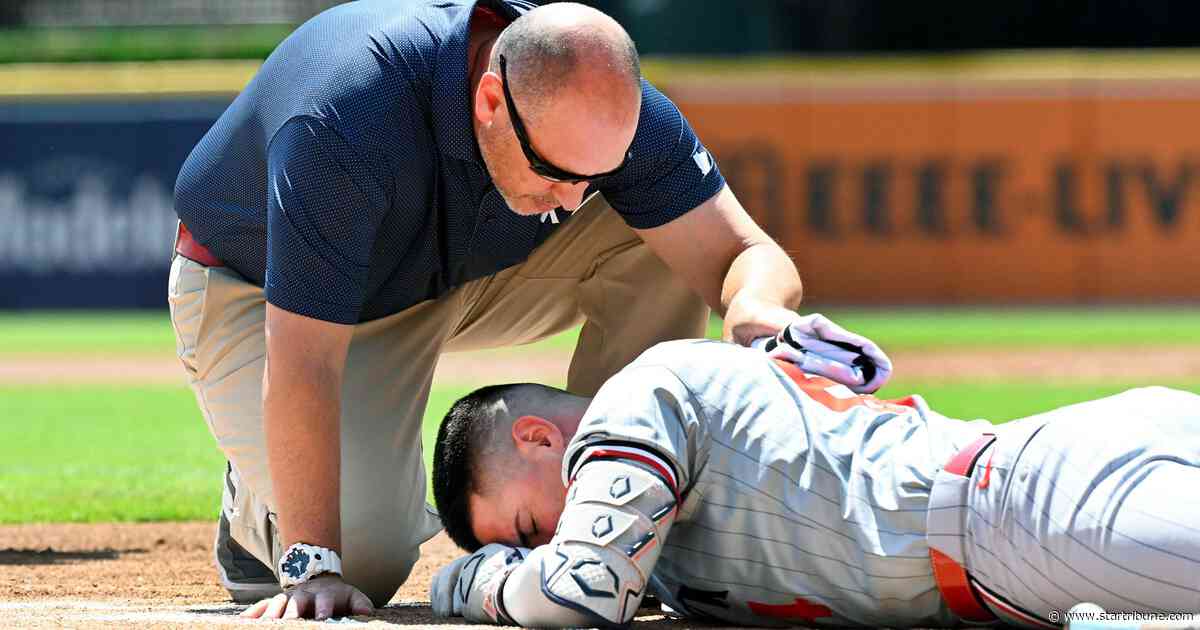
[929,388,1200,628]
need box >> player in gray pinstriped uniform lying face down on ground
[431,341,1200,628]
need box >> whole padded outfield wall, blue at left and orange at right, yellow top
[0,53,1200,307]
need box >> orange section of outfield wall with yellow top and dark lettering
[666,54,1200,304]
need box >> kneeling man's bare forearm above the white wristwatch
[263,364,342,552]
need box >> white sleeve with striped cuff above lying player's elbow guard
[563,362,704,497]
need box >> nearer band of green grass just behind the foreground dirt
[0,383,1200,523]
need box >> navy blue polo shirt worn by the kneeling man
[175,0,725,324]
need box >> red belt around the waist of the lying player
[928,433,996,623]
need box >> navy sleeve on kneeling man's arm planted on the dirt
[265,116,388,324]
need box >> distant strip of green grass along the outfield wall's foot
[0,306,1200,355]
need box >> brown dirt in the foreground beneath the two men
[0,523,683,628]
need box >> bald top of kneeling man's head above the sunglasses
[492,2,642,119]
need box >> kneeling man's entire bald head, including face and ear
[468,2,642,215]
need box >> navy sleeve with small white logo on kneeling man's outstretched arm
[596,79,725,229]
